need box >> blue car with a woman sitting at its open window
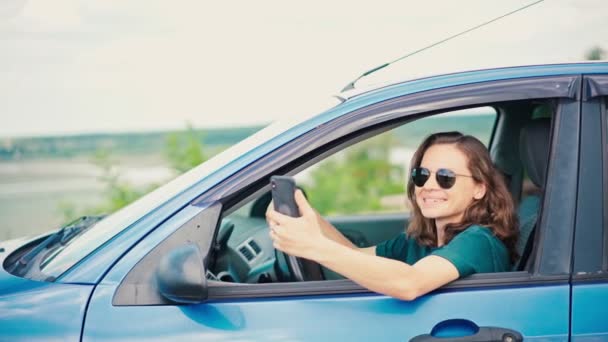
[0,63,608,341]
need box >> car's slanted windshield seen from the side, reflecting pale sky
[40,97,340,278]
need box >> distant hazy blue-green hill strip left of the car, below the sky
[0,126,264,160]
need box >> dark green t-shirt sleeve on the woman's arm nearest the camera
[431,228,493,278]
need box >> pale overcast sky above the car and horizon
[0,0,608,137]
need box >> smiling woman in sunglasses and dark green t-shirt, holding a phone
[267,132,519,300]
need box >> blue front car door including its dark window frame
[83,75,580,341]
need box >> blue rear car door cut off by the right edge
[572,75,608,341]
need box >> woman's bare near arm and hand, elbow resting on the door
[268,192,459,300]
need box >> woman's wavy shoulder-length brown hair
[407,132,519,264]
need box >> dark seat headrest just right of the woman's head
[519,118,551,188]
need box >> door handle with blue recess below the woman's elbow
[410,319,524,342]
